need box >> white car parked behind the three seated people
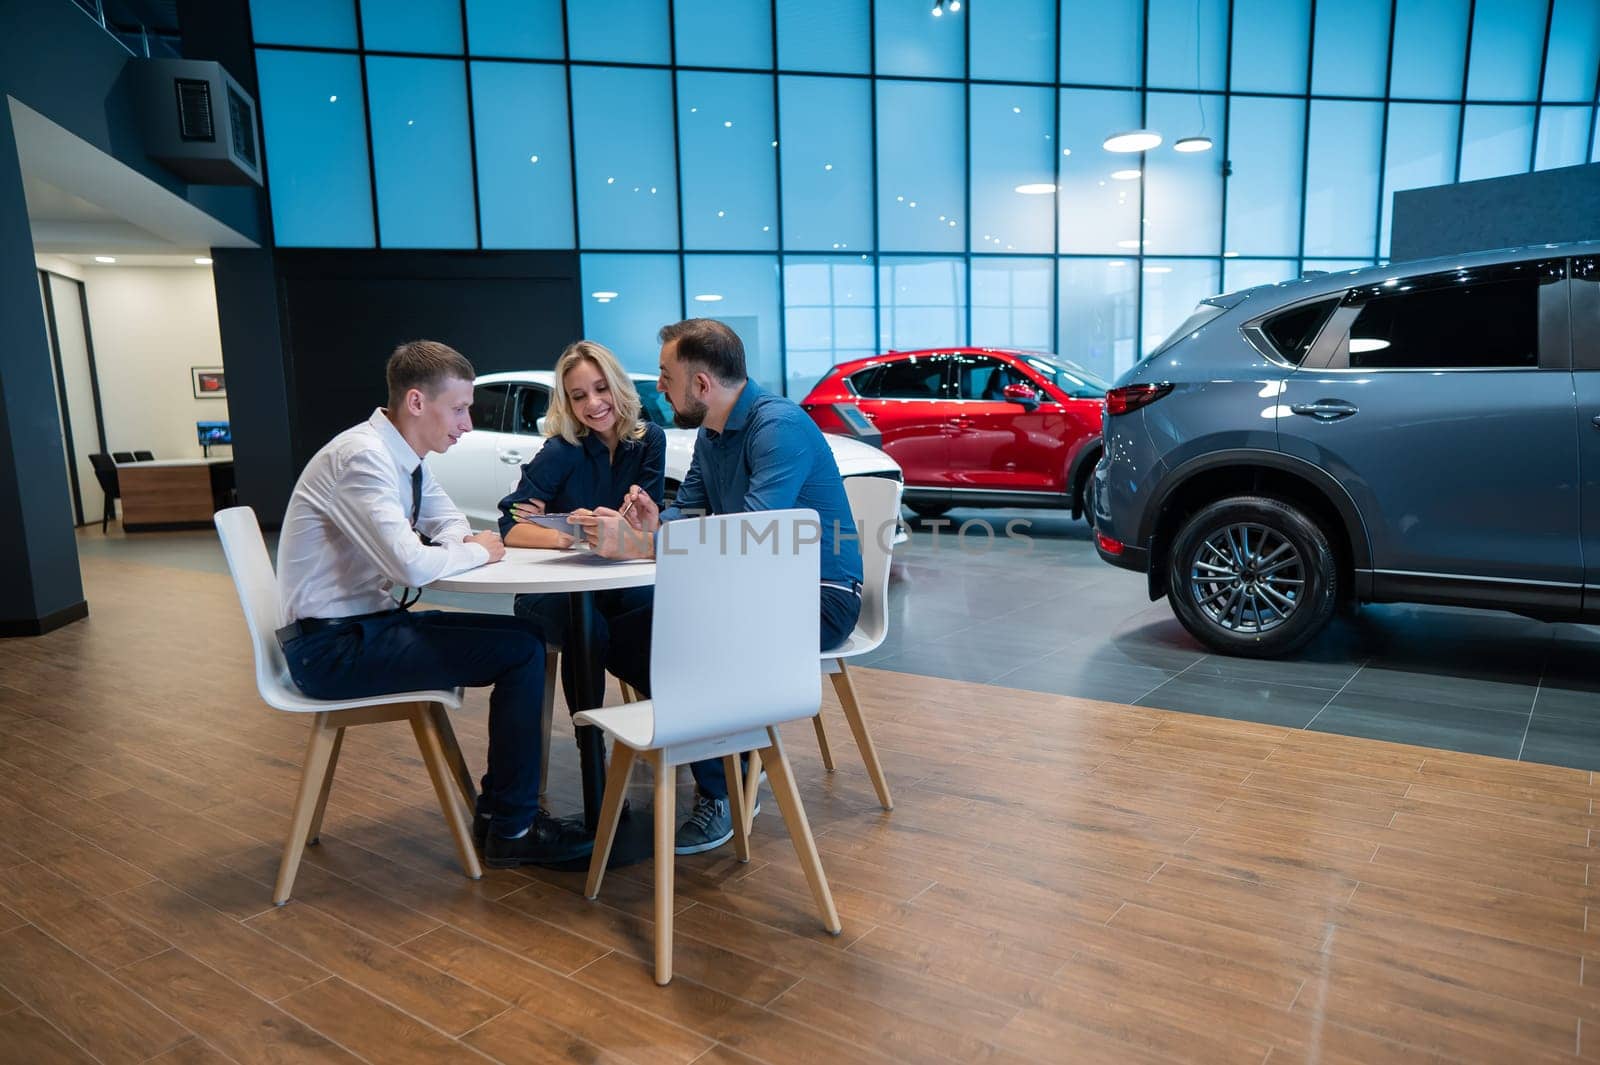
[427,369,902,530]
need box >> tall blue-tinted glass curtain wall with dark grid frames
[251,0,1600,382]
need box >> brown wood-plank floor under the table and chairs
[0,560,1600,1065]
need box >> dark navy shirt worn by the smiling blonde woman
[501,422,667,536]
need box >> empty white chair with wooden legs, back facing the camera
[576,510,840,983]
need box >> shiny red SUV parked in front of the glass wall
[802,347,1107,518]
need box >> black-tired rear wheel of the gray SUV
[1166,496,1339,659]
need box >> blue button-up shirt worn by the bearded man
[661,381,861,584]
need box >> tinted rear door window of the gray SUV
[1347,275,1539,369]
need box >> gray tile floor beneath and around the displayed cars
[78,510,1600,769]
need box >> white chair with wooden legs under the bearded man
[744,477,901,817]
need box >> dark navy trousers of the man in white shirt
[283,611,544,836]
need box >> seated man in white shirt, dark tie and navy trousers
[278,341,594,867]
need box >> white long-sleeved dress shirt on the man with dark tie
[278,408,490,625]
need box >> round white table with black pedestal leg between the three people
[427,547,656,844]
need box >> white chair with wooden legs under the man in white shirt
[214,507,483,905]
